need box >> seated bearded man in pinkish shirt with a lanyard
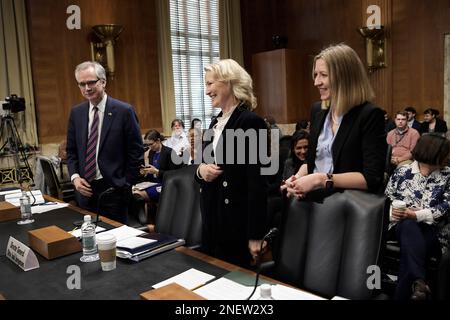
[386,111,420,168]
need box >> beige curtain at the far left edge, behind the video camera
[0,0,38,146]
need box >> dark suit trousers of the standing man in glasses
[79,179,131,224]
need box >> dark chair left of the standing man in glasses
[38,157,75,202]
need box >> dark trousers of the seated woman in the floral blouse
[395,219,440,300]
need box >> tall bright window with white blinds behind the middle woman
[170,0,219,129]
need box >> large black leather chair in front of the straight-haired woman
[274,190,386,299]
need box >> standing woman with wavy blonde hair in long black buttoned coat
[196,59,267,267]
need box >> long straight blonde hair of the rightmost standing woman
[312,43,375,115]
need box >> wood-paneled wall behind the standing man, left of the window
[27,0,162,143]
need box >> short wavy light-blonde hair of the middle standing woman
[204,59,257,110]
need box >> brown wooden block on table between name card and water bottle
[28,226,81,260]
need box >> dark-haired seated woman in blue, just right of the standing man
[133,130,179,222]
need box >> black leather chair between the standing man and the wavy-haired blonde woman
[155,165,202,247]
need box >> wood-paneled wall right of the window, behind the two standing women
[241,0,450,118]
